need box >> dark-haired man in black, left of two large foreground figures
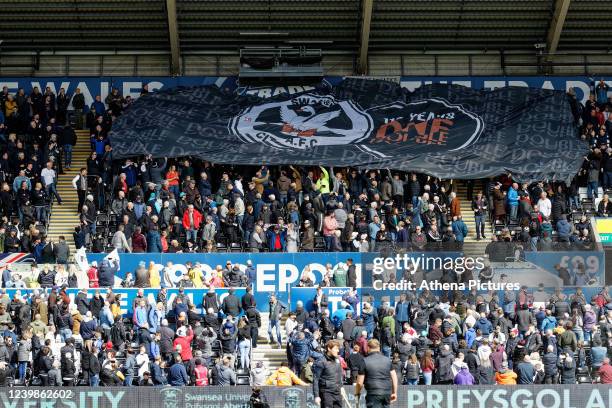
[312,340,343,408]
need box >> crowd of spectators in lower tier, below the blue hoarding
[0,270,612,390]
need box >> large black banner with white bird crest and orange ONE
[111,78,587,181]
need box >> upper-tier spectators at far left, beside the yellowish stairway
[0,86,141,263]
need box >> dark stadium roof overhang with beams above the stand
[0,0,612,67]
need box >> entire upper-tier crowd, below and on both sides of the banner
[0,83,612,253]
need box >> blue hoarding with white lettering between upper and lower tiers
[87,251,605,296]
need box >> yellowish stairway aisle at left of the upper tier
[47,130,91,255]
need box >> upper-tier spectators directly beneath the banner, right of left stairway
[95,157,596,253]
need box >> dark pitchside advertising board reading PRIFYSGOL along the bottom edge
[0,384,612,408]
